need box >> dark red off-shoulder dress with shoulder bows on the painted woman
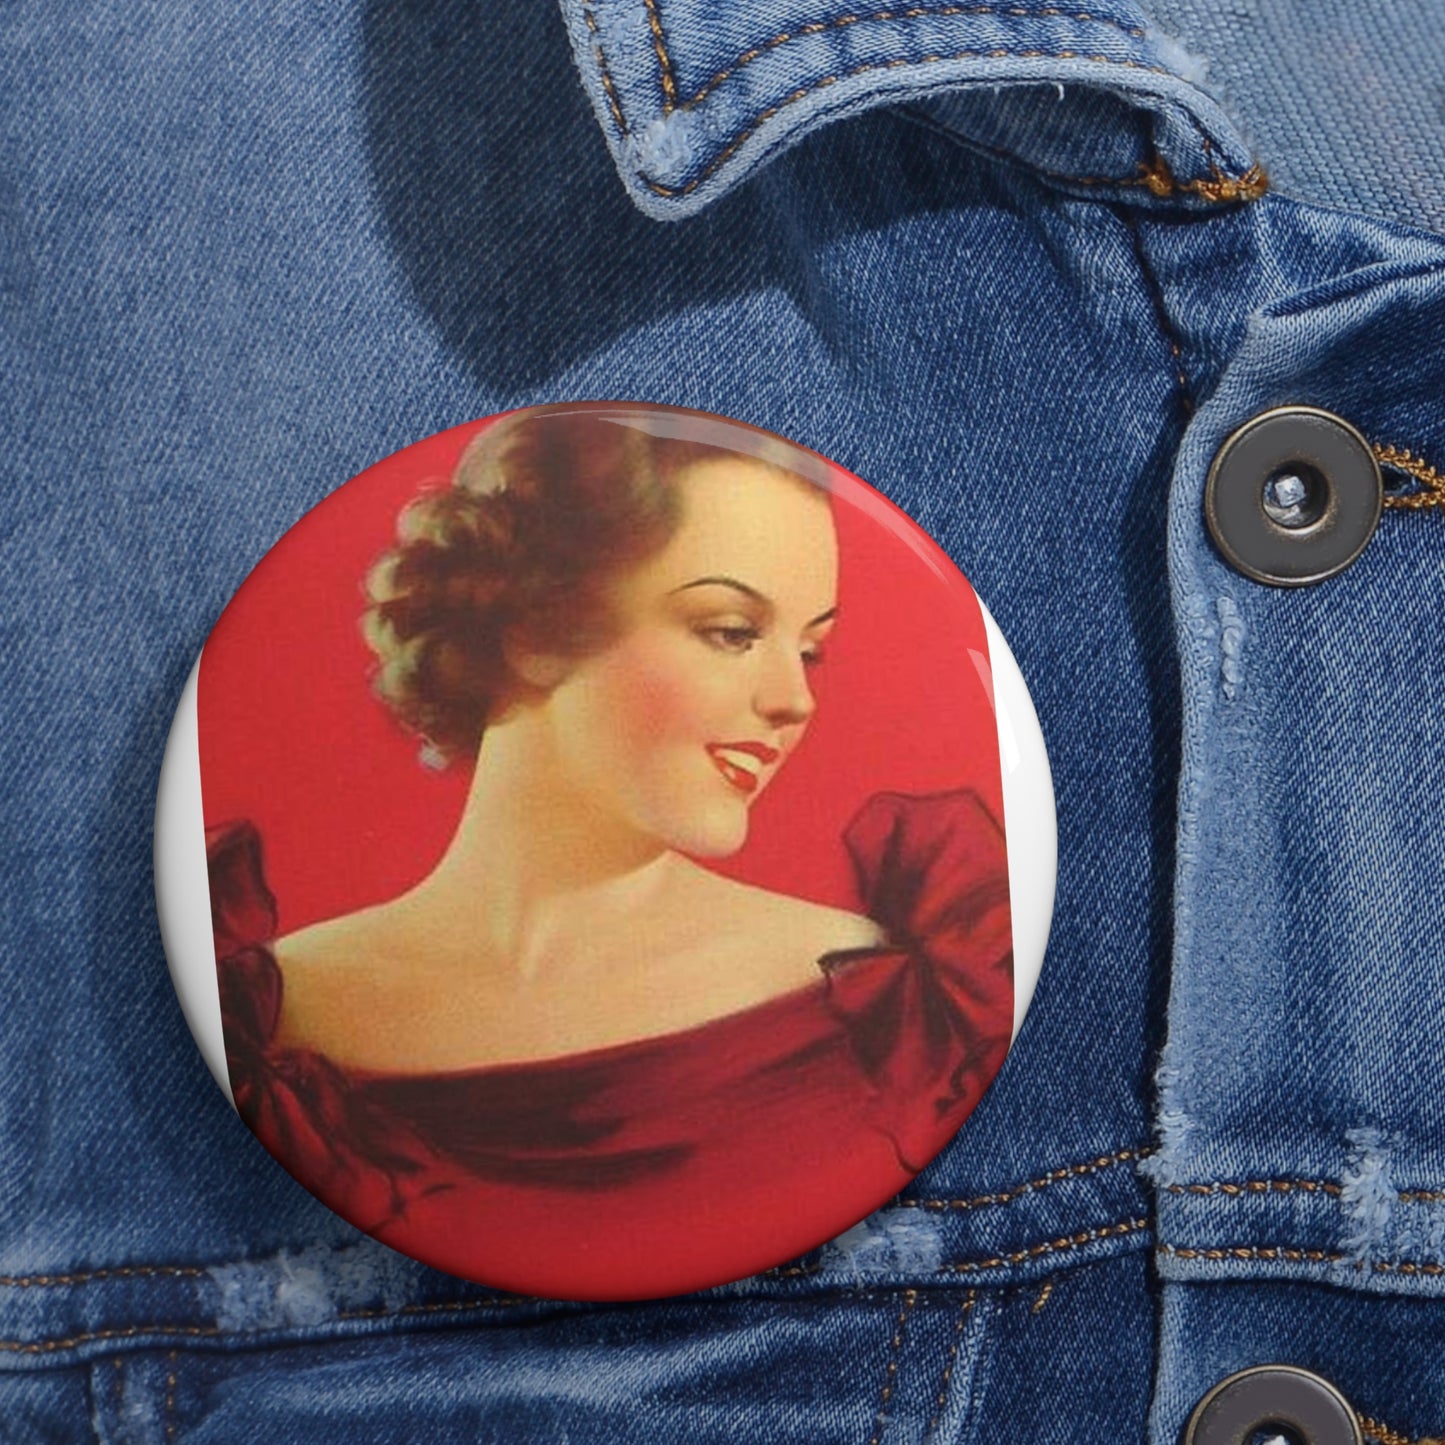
[207,790,1013,1299]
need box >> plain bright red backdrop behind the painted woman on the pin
[199,422,1003,933]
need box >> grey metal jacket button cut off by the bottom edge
[1183,1364,1364,1445]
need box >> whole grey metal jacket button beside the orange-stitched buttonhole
[1204,406,1384,587]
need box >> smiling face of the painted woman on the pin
[543,458,838,857]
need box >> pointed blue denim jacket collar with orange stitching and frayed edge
[562,0,1266,220]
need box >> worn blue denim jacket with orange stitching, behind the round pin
[0,0,1445,1445]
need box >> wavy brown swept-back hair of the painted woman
[363,402,828,762]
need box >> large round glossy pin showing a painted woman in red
[156,402,1055,1299]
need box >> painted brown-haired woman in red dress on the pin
[208,405,1013,1299]
